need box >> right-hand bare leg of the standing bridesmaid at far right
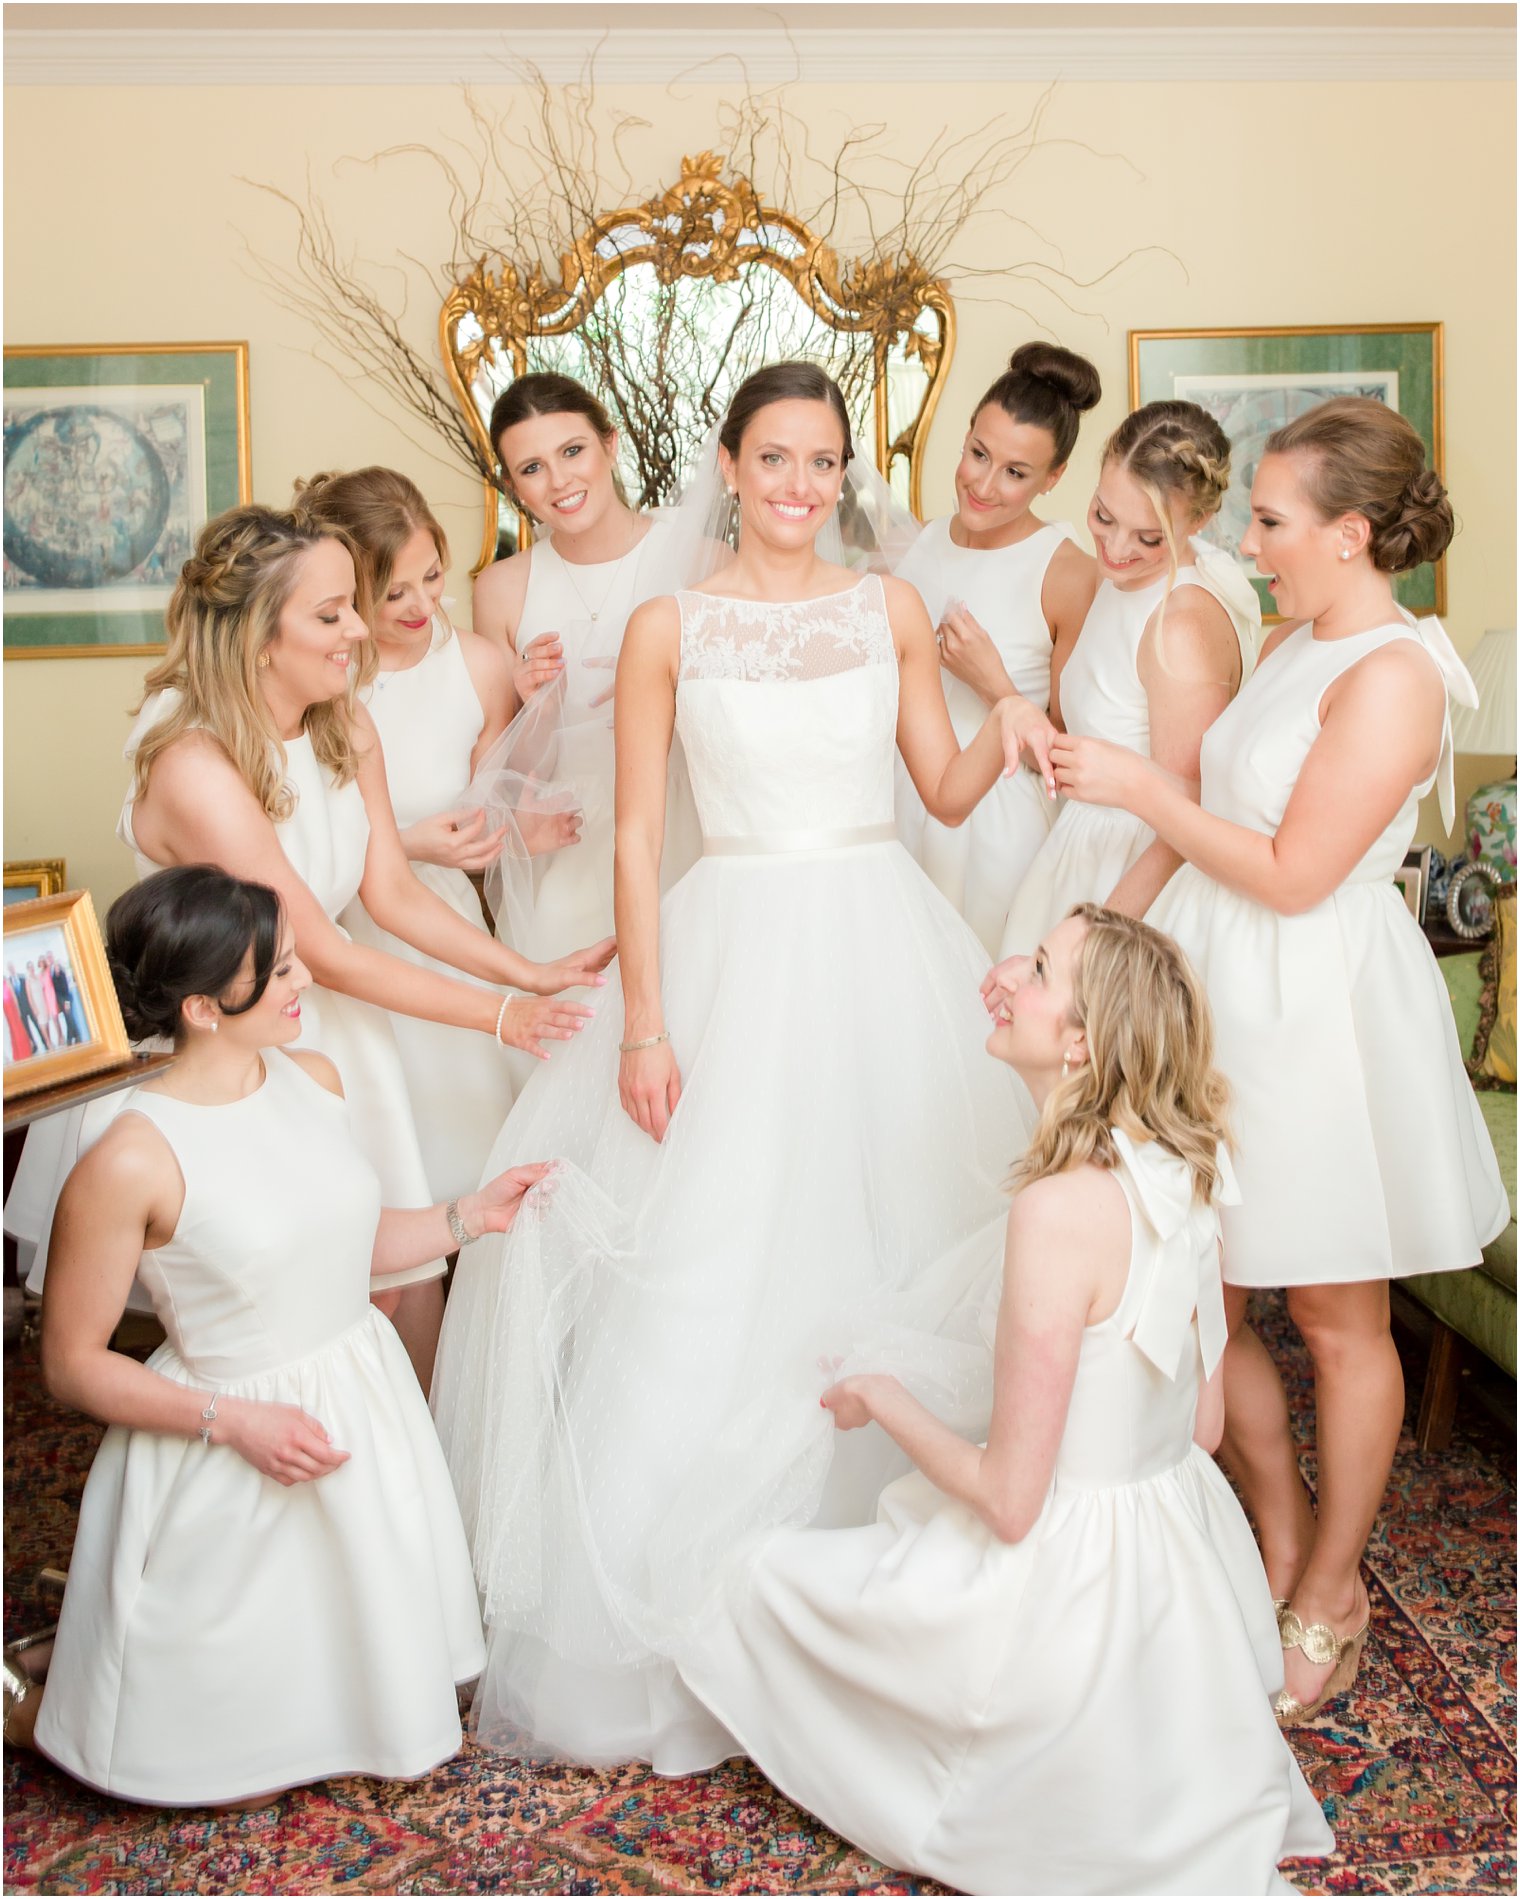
[1283,1280,1404,1703]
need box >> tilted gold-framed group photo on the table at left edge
[0,891,131,1101]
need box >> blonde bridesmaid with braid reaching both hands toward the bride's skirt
[8,505,612,1386]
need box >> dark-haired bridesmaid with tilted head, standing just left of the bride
[473,374,697,972]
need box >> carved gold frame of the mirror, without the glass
[439,152,956,572]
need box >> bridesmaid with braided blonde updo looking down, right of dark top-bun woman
[1001,403,1262,957]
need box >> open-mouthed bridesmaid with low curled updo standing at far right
[1056,397,1509,1720]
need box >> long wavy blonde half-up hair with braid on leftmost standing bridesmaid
[133,503,374,824]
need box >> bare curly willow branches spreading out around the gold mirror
[243,53,1170,503]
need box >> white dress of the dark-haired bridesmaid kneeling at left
[36,1050,483,1806]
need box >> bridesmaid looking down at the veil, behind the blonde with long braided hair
[296,467,580,1200]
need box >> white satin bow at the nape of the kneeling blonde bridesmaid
[1113,1128,1241,1379]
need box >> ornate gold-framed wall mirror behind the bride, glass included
[441,152,954,572]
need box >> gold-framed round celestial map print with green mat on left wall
[4,344,253,659]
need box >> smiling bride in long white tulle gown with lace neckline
[433,363,1032,1774]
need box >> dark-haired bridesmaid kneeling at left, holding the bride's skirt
[6,866,545,1806]
